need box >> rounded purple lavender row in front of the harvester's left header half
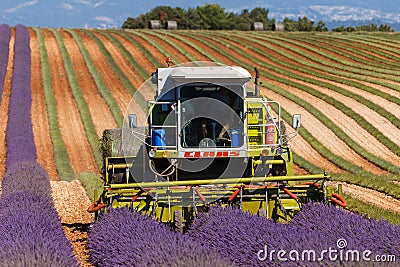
[88,208,233,267]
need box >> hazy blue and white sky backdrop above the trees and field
[0,0,400,28]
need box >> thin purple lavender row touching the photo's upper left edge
[0,24,11,104]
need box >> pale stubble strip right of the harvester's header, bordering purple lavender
[328,182,400,213]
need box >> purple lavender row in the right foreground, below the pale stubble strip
[290,203,400,259]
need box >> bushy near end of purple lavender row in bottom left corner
[0,162,79,267]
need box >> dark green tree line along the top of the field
[122,4,393,32]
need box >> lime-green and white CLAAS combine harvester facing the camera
[88,61,346,231]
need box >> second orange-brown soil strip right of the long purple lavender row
[43,29,98,174]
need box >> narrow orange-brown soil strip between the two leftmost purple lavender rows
[0,28,15,180]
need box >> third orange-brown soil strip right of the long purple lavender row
[60,31,117,137]
